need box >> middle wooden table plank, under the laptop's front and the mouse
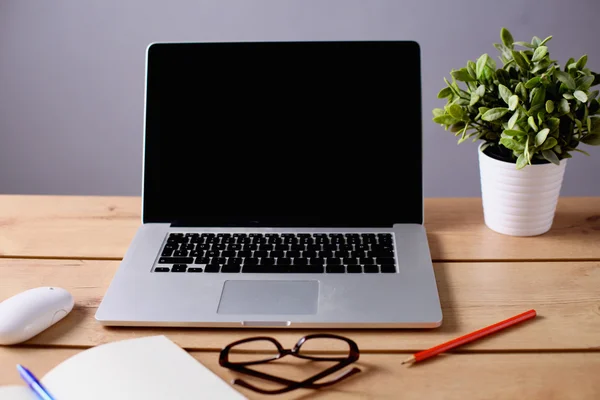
[0,259,600,351]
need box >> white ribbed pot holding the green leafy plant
[478,143,567,236]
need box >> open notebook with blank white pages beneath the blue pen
[0,335,245,400]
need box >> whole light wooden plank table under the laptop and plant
[0,195,600,400]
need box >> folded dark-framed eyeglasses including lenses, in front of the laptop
[219,333,360,394]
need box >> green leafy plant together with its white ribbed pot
[433,28,600,236]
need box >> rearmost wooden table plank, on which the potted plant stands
[0,195,600,261]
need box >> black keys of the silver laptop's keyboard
[154,233,396,274]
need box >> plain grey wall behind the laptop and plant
[0,0,600,197]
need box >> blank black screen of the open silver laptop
[143,41,423,227]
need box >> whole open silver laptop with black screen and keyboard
[96,41,442,329]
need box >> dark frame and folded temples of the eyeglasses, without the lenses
[219,333,361,394]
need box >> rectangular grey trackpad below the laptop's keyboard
[217,281,319,315]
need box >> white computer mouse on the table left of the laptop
[0,287,75,345]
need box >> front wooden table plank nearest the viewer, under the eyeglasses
[0,348,600,400]
